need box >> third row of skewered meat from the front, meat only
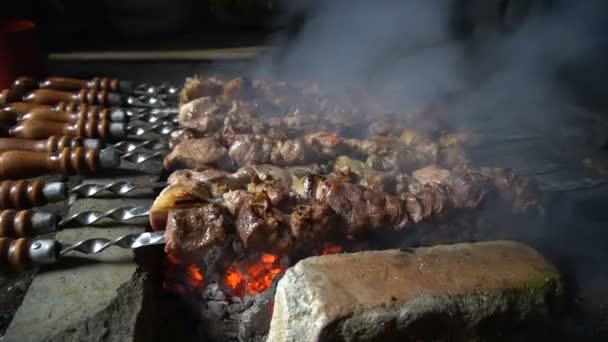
[164,132,446,172]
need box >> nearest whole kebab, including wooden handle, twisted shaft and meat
[0,162,548,270]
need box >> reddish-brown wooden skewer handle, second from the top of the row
[23,89,123,107]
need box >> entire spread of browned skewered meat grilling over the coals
[162,77,539,260]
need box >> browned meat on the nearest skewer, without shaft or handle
[166,167,488,260]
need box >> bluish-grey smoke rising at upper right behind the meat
[255,0,608,136]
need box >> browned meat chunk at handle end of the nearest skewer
[165,204,233,262]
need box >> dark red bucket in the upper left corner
[0,20,46,90]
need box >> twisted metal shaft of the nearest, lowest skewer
[59,231,165,256]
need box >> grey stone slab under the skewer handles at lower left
[3,174,157,342]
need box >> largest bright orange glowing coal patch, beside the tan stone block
[224,253,284,297]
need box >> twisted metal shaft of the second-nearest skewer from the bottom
[58,206,150,226]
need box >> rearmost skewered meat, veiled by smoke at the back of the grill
[179,77,441,140]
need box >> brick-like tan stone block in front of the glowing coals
[268,241,563,342]
